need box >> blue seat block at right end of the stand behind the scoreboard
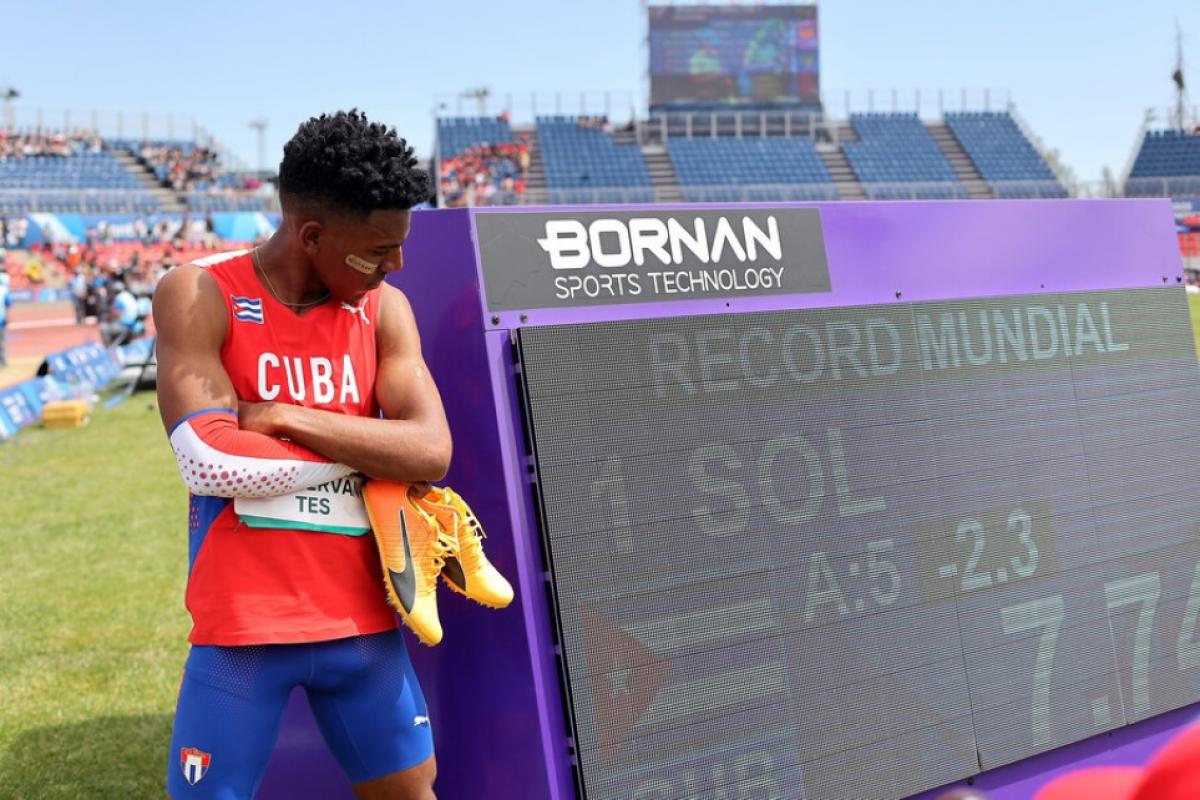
[946,112,1067,198]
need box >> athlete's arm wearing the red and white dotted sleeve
[154,266,353,498]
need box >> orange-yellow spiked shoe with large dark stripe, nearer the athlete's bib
[362,480,457,645]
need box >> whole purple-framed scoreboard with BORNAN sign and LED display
[255,200,1200,800]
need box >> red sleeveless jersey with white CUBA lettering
[187,253,398,645]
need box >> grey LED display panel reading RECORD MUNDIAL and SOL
[518,288,1200,800]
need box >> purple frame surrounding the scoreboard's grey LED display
[259,200,1200,800]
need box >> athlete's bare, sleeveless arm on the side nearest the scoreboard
[241,283,452,483]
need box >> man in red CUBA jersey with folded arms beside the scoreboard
[154,112,451,800]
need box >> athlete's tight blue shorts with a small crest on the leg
[167,630,433,800]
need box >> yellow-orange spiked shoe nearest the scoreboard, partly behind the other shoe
[413,486,512,608]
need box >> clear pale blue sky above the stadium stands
[0,0,1200,181]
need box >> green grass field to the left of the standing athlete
[0,393,190,800]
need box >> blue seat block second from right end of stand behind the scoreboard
[841,113,967,200]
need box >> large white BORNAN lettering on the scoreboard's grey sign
[538,216,784,270]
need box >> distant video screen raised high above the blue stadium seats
[648,5,821,107]
